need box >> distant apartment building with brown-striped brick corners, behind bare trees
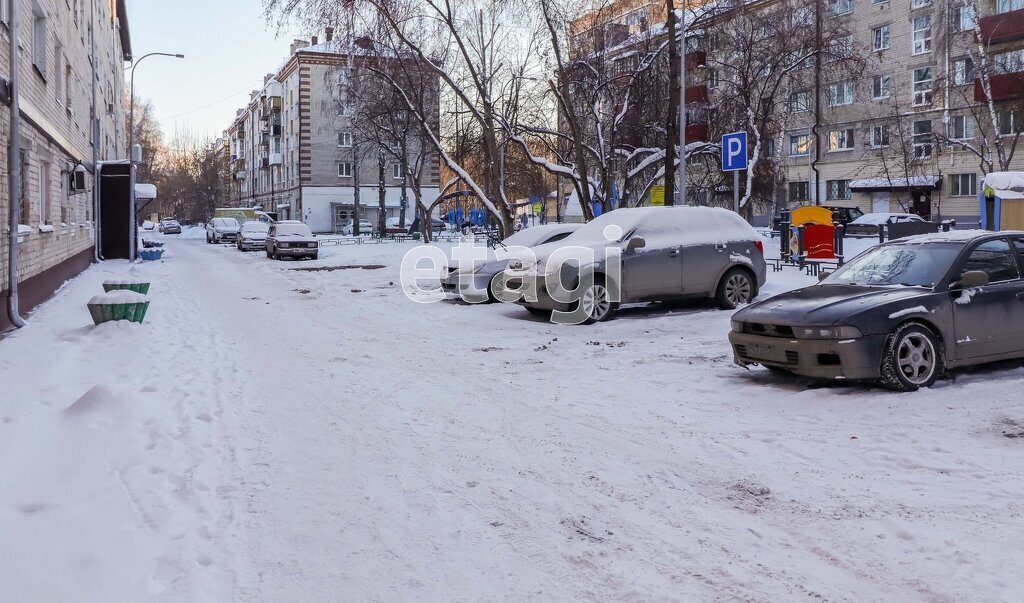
[225,31,439,232]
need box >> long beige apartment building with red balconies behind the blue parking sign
[570,0,1024,225]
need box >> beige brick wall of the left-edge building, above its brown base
[0,0,125,289]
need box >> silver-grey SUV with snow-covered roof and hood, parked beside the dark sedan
[505,207,766,324]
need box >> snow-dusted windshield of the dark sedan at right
[821,243,964,287]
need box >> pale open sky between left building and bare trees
[125,0,296,142]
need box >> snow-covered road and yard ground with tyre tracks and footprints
[0,232,1024,601]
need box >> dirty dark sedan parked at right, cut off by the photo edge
[729,230,1024,391]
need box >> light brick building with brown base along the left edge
[0,0,131,330]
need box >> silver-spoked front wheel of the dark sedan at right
[881,322,945,391]
